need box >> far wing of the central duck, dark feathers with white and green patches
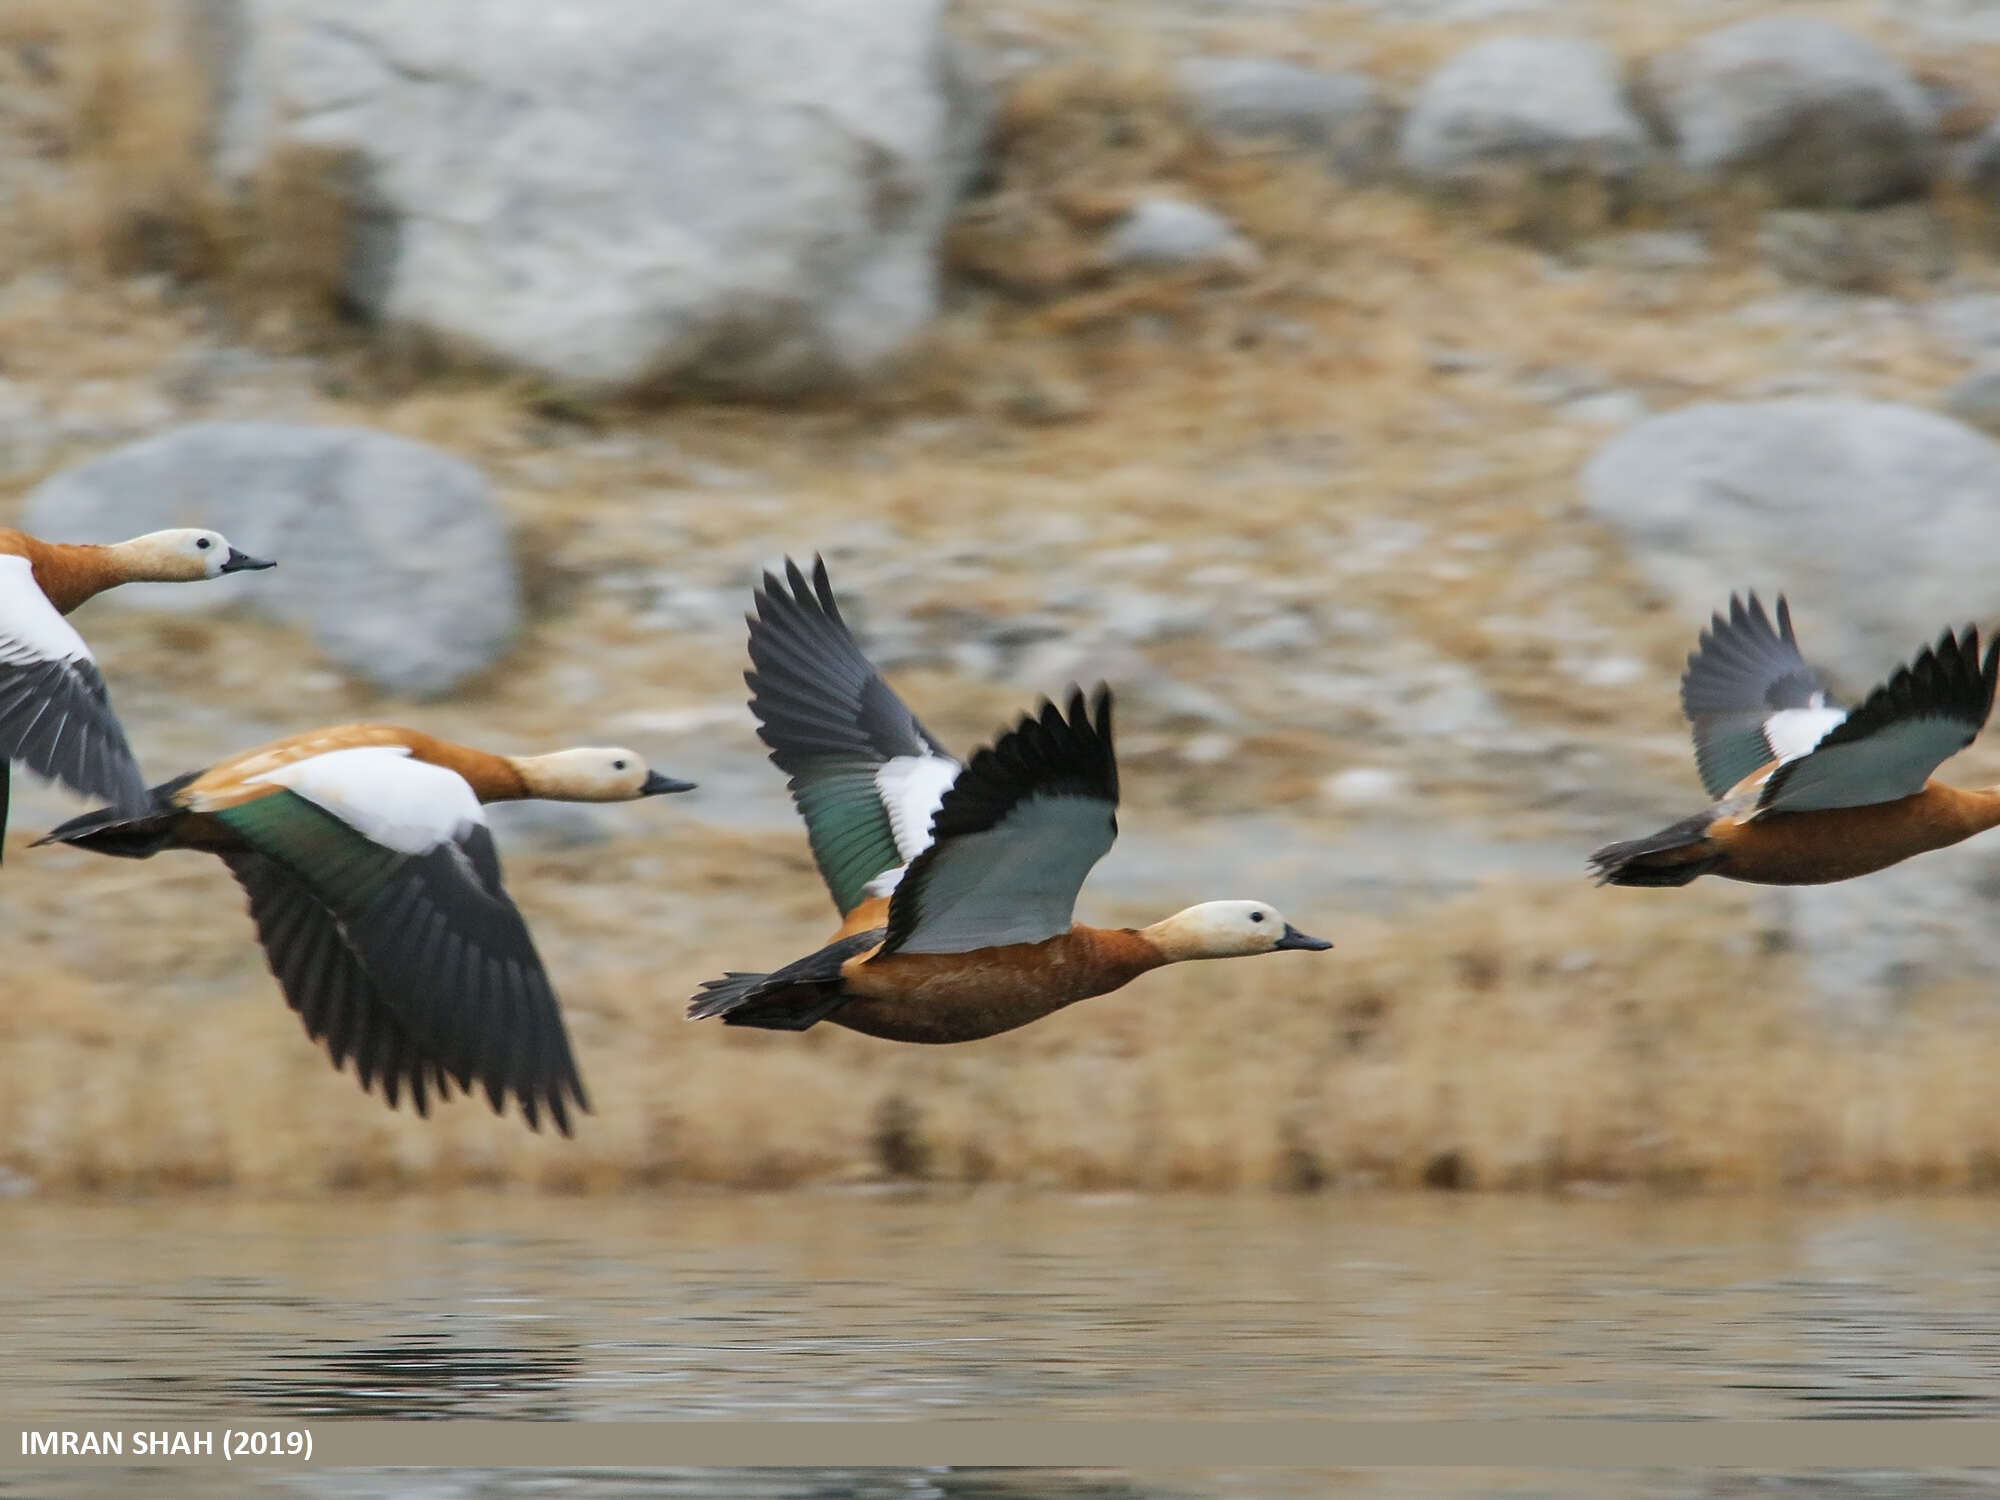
[744,558,958,914]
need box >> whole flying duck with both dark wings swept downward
[42,724,692,1134]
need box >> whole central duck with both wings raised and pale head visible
[688,560,1332,1042]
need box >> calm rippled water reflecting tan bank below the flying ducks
[0,1192,2000,1496]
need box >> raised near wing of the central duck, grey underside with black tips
[882,688,1118,954]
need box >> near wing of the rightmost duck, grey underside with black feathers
[1756,628,2000,814]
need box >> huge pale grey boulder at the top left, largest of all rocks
[205,0,980,394]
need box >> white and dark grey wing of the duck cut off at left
[0,556,146,832]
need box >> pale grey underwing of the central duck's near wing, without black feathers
[898,796,1116,954]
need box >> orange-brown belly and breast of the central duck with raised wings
[828,928,1166,1042]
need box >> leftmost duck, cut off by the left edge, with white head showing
[0,528,276,856]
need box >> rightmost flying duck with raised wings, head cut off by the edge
[1590,594,2000,886]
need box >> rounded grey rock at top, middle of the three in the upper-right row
[1402,36,1652,186]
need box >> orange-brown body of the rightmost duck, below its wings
[1688,782,2000,886]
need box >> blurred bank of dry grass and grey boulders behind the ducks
[0,0,2000,1192]
